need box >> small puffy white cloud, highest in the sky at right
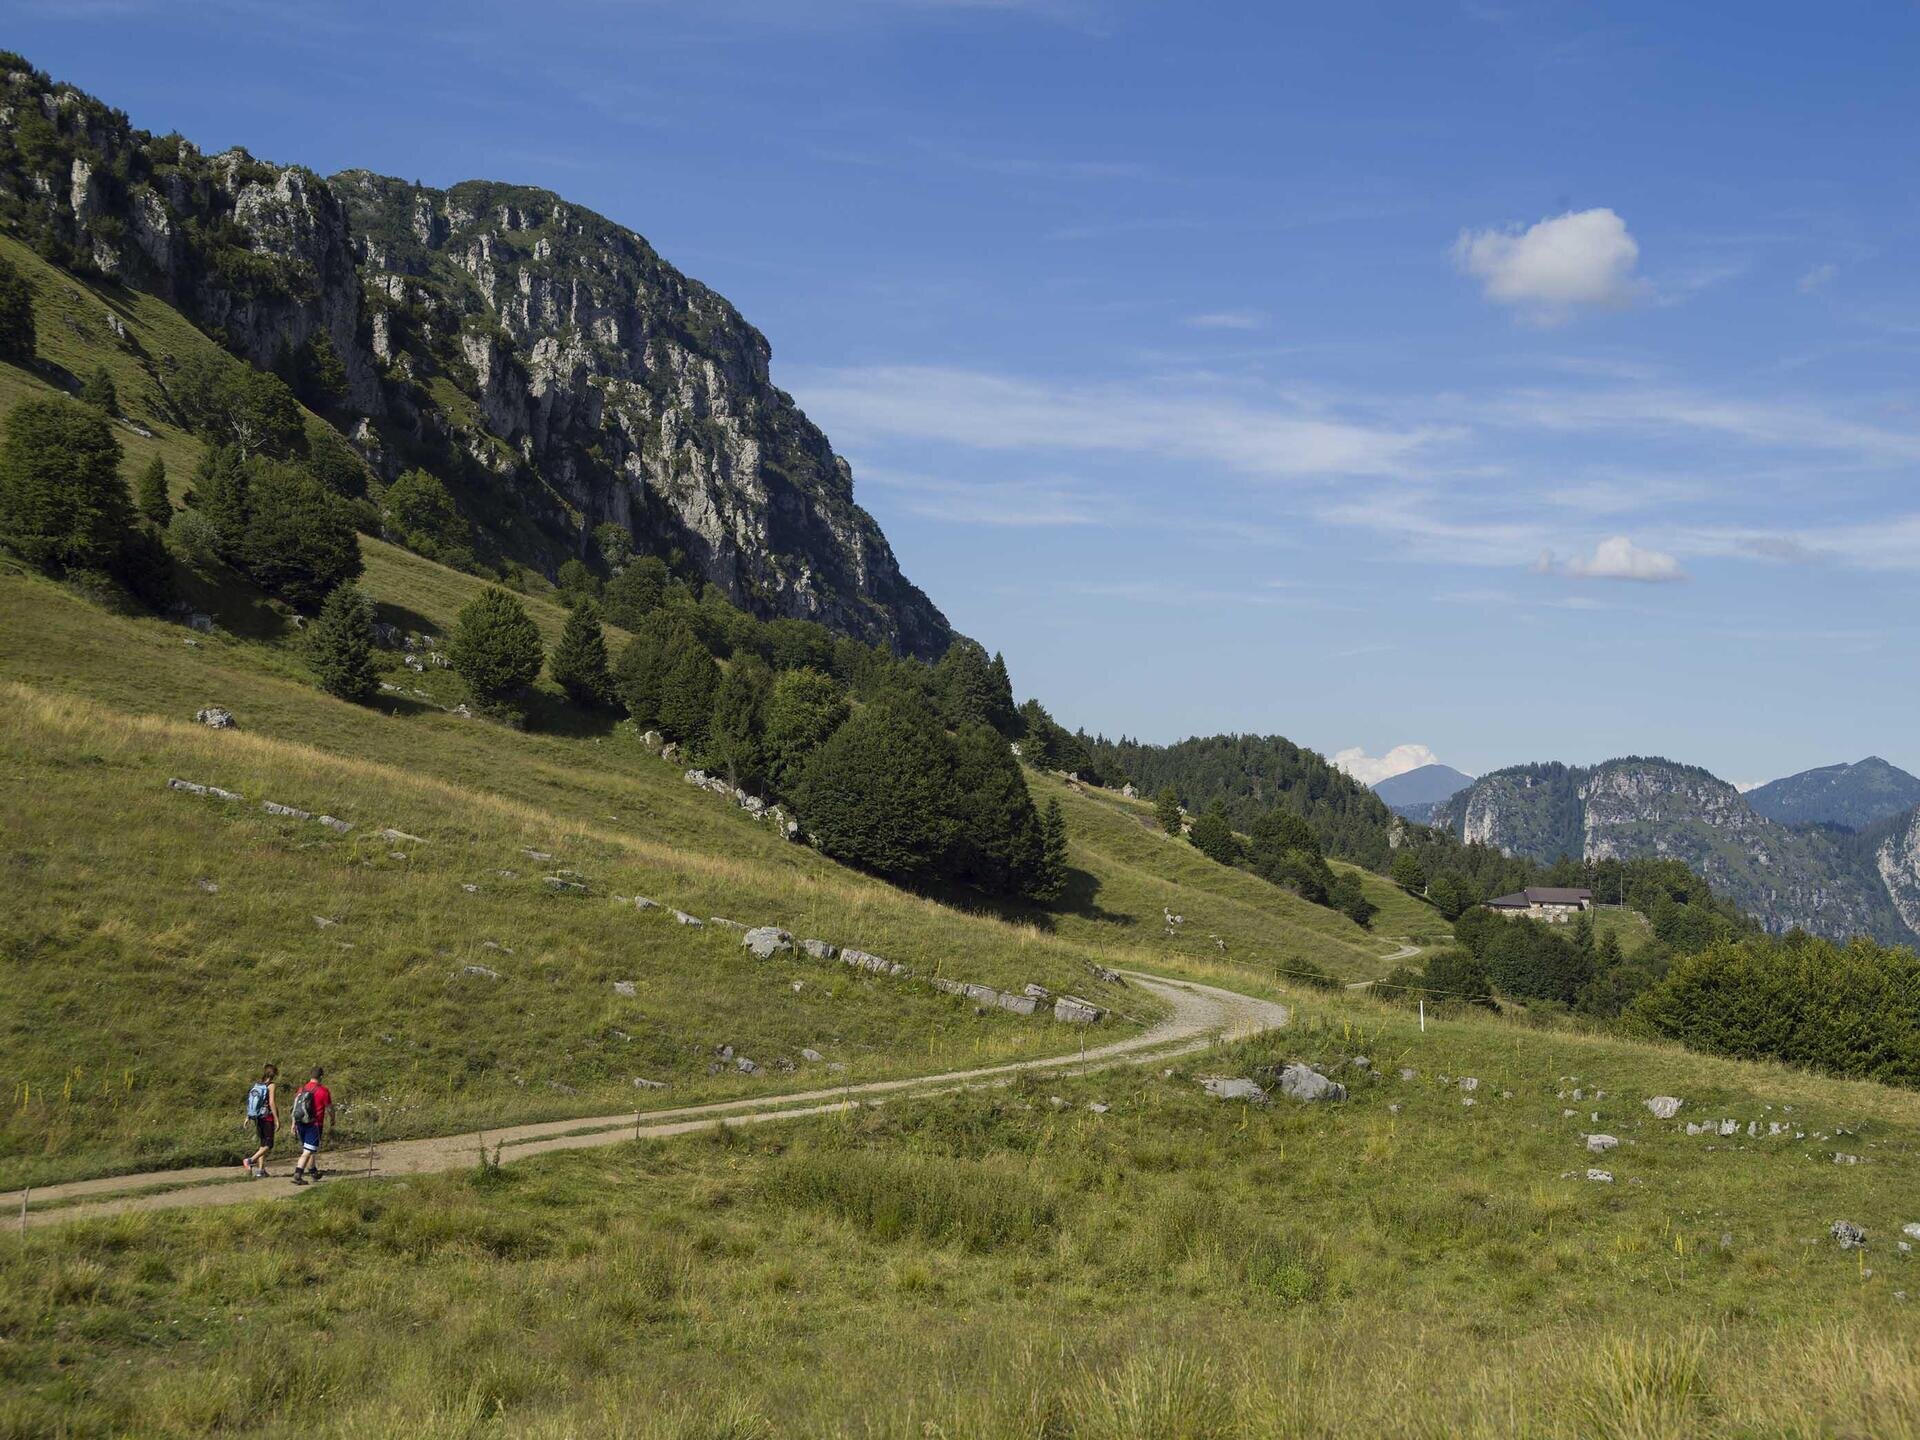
[1453,209,1647,324]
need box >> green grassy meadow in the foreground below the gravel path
[0,971,1920,1440]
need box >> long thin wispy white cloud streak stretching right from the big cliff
[793,365,1446,480]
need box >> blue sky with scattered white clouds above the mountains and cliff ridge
[15,0,1920,781]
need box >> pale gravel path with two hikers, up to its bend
[0,972,1288,1229]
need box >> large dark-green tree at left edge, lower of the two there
[0,397,132,570]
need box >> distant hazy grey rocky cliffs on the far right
[1434,756,1920,943]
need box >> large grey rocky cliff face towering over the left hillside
[0,56,950,657]
